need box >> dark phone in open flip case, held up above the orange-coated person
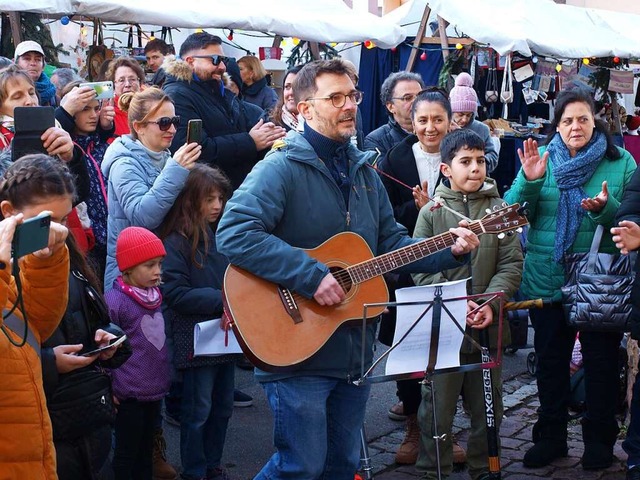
[11,107,56,162]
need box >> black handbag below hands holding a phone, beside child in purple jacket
[47,368,116,440]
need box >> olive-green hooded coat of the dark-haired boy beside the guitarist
[412,178,522,353]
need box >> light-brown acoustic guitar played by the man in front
[224,204,528,372]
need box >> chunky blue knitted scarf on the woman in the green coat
[547,130,607,262]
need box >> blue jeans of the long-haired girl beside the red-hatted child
[180,362,235,478]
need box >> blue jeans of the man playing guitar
[254,376,370,480]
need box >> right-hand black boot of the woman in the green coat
[580,418,619,470]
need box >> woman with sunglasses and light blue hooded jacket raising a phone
[102,87,202,291]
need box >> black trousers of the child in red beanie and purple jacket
[113,400,162,480]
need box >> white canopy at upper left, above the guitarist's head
[0,0,405,48]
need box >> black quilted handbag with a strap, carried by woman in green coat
[561,225,635,332]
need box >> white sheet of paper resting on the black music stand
[385,279,467,375]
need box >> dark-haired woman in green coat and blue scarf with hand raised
[505,90,636,470]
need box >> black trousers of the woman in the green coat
[529,306,622,437]
